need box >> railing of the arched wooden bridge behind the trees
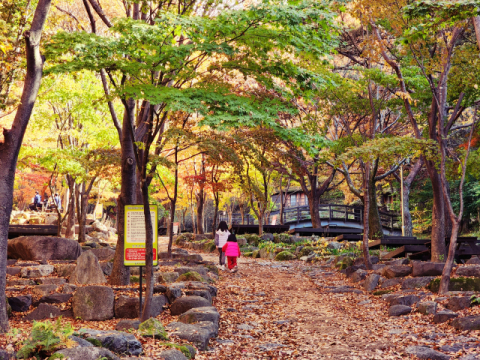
[220,204,401,229]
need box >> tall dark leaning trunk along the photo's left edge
[0,0,51,333]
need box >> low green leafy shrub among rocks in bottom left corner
[17,318,75,359]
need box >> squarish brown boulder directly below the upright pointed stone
[72,286,115,321]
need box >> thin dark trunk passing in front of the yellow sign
[140,179,154,322]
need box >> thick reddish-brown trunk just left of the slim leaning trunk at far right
[426,161,446,262]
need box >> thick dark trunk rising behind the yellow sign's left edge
[110,100,136,285]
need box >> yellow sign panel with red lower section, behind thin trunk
[123,205,158,266]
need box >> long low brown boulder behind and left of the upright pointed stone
[7,236,82,260]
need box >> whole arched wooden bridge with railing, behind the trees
[220,204,401,235]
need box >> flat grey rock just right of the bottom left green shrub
[79,328,143,356]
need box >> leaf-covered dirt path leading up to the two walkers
[159,238,405,359]
